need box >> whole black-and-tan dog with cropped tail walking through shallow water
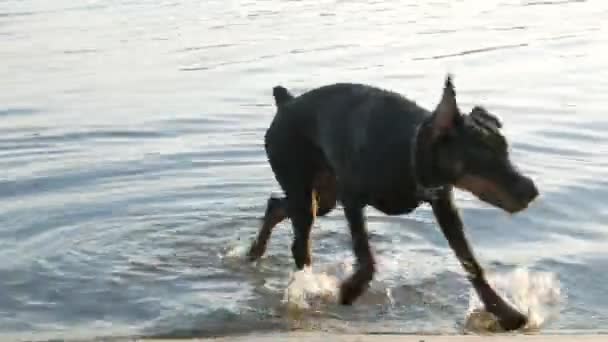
[249,75,538,330]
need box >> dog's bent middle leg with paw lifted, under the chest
[340,200,376,305]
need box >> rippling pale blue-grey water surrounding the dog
[0,0,608,339]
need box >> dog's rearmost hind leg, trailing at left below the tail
[247,197,287,261]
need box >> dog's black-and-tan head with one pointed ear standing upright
[431,75,538,213]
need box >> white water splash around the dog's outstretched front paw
[466,268,563,332]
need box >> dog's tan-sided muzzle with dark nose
[454,175,538,214]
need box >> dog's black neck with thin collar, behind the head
[410,118,448,202]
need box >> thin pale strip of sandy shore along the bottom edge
[144,333,608,342]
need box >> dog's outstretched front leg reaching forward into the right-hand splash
[432,191,527,330]
